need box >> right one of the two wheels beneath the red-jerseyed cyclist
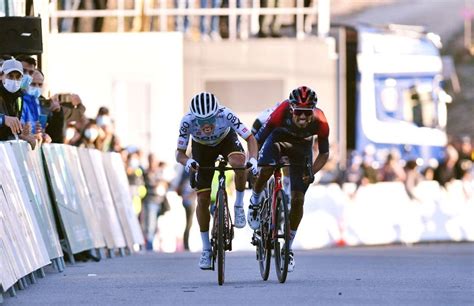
[273,190,290,283]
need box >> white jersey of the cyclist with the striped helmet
[178,107,251,150]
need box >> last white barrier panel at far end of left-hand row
[103,153,145,250]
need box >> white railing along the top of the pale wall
[49,0,330,40]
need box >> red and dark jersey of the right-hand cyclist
[255,100,329,153]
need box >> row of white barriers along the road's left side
[0,141,144,301]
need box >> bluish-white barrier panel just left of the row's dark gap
[9,142,63,259]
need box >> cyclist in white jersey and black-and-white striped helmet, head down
[176,92,258,270]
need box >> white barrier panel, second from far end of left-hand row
[89,150,126,248]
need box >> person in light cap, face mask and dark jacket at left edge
[0,58,23,140]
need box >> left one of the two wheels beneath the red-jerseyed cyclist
[257,199,272,280]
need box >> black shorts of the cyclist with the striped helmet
[191,130,244,191]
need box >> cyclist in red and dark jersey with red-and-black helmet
[247,86,329,272]
